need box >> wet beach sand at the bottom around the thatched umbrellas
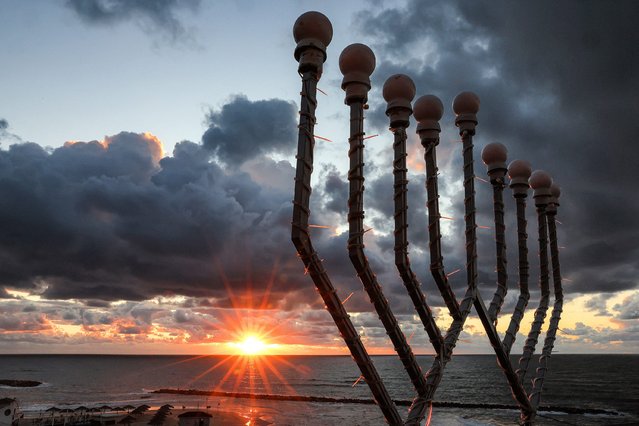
[19,395,624,426]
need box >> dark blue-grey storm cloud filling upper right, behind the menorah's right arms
[358,1,639,292]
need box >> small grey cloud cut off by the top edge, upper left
[66,0,200,39]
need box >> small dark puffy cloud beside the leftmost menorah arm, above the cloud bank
[202,96,297,167]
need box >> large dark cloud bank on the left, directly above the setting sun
[0,95,315,308]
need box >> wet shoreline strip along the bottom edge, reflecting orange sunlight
[18,396,634,426]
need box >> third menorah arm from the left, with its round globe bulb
[383,74,444,353]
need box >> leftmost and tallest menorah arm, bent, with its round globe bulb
[291,12,402,425]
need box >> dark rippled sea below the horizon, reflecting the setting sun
[0,354,639,426]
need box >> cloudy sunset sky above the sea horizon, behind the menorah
[0,0,639,354]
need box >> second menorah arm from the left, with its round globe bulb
[339,43,429,421]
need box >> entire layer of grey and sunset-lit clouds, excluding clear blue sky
[0,0,639,348]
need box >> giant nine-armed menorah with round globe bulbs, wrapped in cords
[292,12,563,425]
